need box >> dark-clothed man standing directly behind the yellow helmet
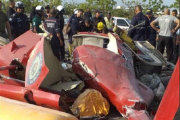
[92,10,106,30]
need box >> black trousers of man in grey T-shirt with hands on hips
[157,36,173,62]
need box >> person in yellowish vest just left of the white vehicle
[104,12,114,30]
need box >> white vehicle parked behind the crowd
[113,17,131,30]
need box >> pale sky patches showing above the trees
[62,0,175,6]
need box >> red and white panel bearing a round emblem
[25,38,49,89]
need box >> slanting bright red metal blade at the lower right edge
[154,60,180,120]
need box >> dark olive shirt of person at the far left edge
[0,11,8,32]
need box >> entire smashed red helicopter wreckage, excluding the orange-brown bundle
[0,31,179,120]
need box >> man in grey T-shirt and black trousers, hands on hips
[151,8,179,62]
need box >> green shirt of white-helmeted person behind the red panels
[32,15,43,33]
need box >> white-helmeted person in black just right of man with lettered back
[56,5,65,61]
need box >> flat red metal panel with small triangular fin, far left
[0,31,41,86]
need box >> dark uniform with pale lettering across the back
[45,17,65,60]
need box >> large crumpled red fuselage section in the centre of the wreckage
[73,45,152,120]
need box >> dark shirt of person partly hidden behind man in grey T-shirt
[148,17,157,41]
